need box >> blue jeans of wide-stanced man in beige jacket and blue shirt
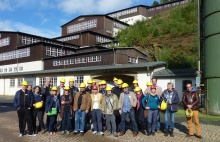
[120,110,138,132]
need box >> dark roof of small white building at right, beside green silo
[153,69,196,77]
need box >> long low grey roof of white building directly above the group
[0,62,166,78]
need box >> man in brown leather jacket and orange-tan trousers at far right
[182,83,203,139]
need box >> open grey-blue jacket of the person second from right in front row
[160,89,179,112]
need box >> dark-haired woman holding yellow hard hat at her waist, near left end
[32,86,45,134]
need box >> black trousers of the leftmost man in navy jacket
[17,108,33,135]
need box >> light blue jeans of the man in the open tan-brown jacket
[75,109,86,132]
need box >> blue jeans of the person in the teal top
[147,110,158,133]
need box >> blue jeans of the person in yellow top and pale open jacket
[92,109,102,132]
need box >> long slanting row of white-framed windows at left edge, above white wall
[0,47,30,61]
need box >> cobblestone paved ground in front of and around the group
[0,96,220,142]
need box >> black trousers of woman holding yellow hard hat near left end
[32,109,44,132]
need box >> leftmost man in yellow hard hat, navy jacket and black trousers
[14,81,36,137]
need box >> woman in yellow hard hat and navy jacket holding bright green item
[45,86,60,135]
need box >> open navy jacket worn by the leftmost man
[14,89,33,109]
